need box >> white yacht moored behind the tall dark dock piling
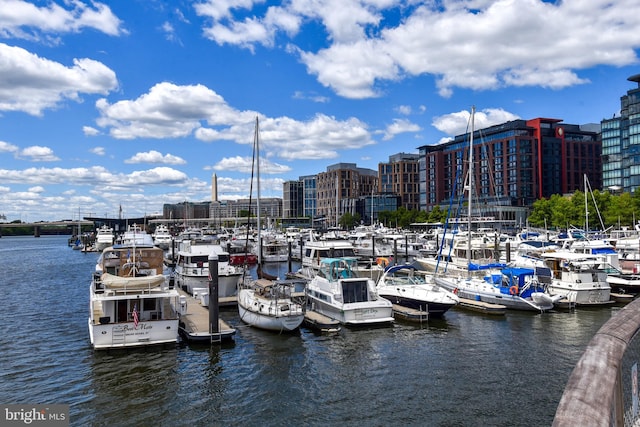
[174,235,244,298]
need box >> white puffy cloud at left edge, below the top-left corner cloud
[0,43,117,116]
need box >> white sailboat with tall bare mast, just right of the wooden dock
[238,117,304,332]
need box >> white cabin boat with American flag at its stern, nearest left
[88,245,180,350]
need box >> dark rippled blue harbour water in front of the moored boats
[0,236,620,426]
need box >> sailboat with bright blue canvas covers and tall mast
[434,107,562,312]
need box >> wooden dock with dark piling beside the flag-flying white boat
[176,288,236,343]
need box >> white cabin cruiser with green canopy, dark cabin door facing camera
[307,257,393,326]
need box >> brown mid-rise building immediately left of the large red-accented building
[378,153,420,210]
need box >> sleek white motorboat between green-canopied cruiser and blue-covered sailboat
[376,264,460,317]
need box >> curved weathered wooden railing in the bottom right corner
[553,299,640,427]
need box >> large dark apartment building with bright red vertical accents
[419,118,602,225]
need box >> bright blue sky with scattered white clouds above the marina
[0,0,640,222]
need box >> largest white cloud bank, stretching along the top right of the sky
[196,0,640,99]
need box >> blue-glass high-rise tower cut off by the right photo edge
[600,74,640,192]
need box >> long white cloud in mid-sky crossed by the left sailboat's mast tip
[96,82,375,160]
